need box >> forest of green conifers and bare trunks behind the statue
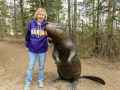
[0,0,120,61]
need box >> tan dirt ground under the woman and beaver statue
[0,41,120,90]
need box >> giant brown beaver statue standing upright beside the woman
[45,22,105,90]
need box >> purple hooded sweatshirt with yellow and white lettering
[25,19,48,53]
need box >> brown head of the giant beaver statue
[45,22,67,40]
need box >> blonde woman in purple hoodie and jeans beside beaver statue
[24,8,48,90]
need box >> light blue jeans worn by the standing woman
[26,52,46,83]
